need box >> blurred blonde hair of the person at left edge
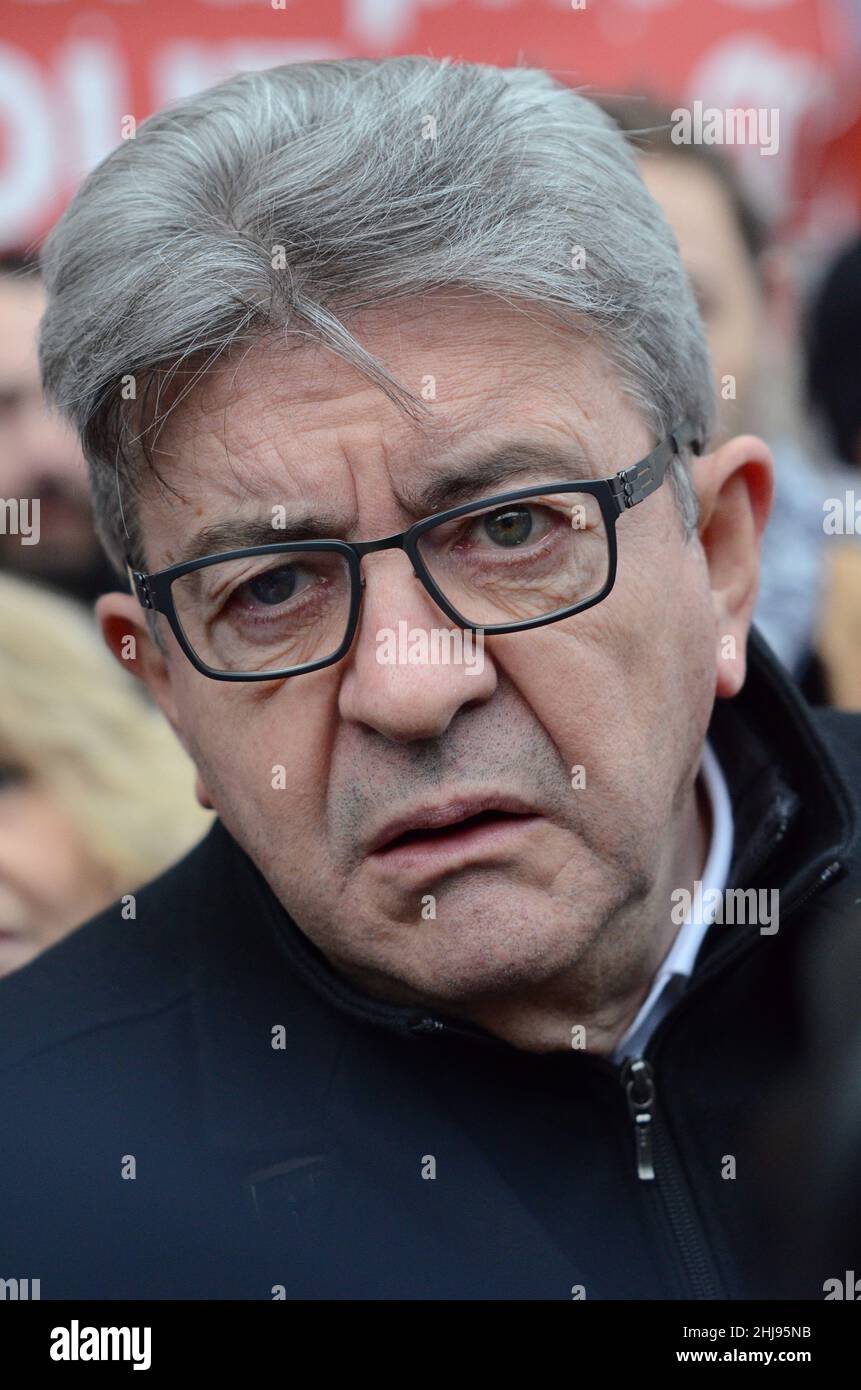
[0,574,213,897]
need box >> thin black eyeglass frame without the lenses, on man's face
[125,420,702,681]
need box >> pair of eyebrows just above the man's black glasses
[174,441,594,564]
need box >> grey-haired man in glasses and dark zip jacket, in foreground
[0,57,861,1300]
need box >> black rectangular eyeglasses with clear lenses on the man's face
[128,421,702,681]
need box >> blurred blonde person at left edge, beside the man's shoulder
[0,575,211,976]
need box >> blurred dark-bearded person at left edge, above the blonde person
[0,253,114,602]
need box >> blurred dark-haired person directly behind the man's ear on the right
[601,96,826,702]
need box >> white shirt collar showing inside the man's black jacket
[612,739,734,1062]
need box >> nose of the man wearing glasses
[339,552,497,744]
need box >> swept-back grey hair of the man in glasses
[39,57,714,569]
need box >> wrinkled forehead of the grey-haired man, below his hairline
[156,319,619,484]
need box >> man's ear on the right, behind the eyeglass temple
[691,435,775,699]
